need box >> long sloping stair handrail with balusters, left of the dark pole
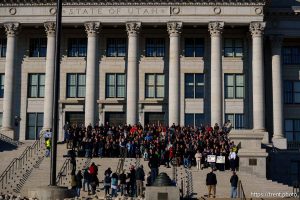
[0,130,45,189]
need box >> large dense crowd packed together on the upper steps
[64,121,238,170]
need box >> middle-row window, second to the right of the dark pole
[106,74,126,98]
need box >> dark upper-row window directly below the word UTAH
[146,38,165,57]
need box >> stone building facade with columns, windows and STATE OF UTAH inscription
[0,0,300,148]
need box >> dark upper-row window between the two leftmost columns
[29,38,47,57]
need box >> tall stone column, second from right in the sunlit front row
[208,22,224,126]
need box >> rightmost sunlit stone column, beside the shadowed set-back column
[250,22,265,131]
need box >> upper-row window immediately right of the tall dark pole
[68,38,87,57]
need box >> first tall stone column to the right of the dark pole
[84,22,100,126]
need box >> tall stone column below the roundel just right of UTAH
[167,22,182,126]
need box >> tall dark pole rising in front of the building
[50,0,62,186]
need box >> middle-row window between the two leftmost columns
[28,74,45,98]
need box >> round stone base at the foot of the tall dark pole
[28,186,76,200]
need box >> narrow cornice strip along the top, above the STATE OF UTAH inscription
[0,0,267,7]
